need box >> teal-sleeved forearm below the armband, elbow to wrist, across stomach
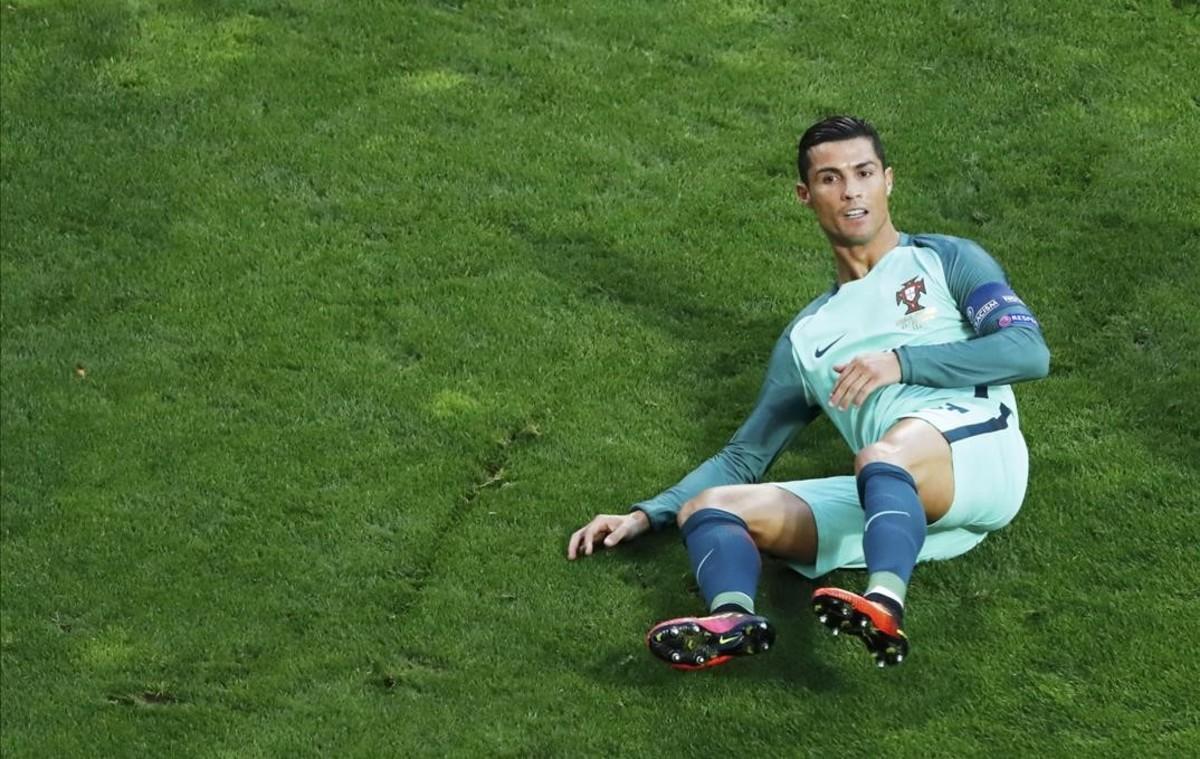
[895,328,1050,388]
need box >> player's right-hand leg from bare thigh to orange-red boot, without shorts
[812,419,954,667]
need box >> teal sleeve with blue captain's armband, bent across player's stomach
[895,234,1050,388]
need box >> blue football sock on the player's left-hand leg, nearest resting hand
[683,509,762,614]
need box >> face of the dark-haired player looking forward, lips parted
[796,137,892,246]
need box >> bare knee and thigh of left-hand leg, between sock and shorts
[679,485,817,561]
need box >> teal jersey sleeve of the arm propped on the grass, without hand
[632,293,830,530]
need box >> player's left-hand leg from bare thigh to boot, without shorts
[646,485,816,669]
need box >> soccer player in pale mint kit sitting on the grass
[566,116,1050,669]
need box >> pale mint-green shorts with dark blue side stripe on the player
[774,399,1030,578]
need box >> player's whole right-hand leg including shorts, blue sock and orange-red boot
[814,395,1028,665]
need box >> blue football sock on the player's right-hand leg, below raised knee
[858,461,925,610]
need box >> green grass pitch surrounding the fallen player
[0,0,1200,758]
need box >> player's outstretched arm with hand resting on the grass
[566,313,820,558]
